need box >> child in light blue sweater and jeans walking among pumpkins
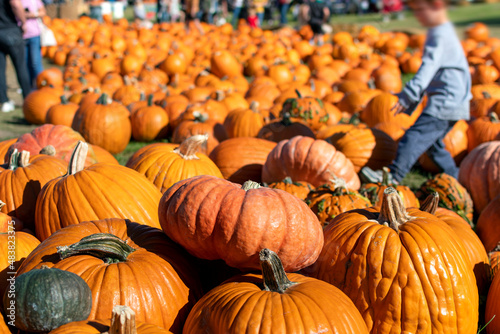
[360,0,472,182]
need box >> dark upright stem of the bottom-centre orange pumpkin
[259,248,296,293]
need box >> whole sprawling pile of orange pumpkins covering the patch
[0,14,500,333]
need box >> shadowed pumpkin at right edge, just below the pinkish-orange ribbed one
[476,195,500,252]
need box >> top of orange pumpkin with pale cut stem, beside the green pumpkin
[49,305,172,334]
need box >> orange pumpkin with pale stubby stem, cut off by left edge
[0,150,66,231]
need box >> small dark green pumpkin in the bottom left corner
[3,266,92,332]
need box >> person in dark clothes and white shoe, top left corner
[0,0,31,112]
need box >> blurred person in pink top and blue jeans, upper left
[21,0,46,87]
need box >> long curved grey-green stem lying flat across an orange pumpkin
[57,233,135,263]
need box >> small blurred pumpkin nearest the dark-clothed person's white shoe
[23,87,61,124]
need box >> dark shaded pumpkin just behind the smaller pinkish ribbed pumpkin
[257,109,315,143]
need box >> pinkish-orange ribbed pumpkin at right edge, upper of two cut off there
[458,140,500,213]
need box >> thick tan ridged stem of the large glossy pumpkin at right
[378,187,412,232]
